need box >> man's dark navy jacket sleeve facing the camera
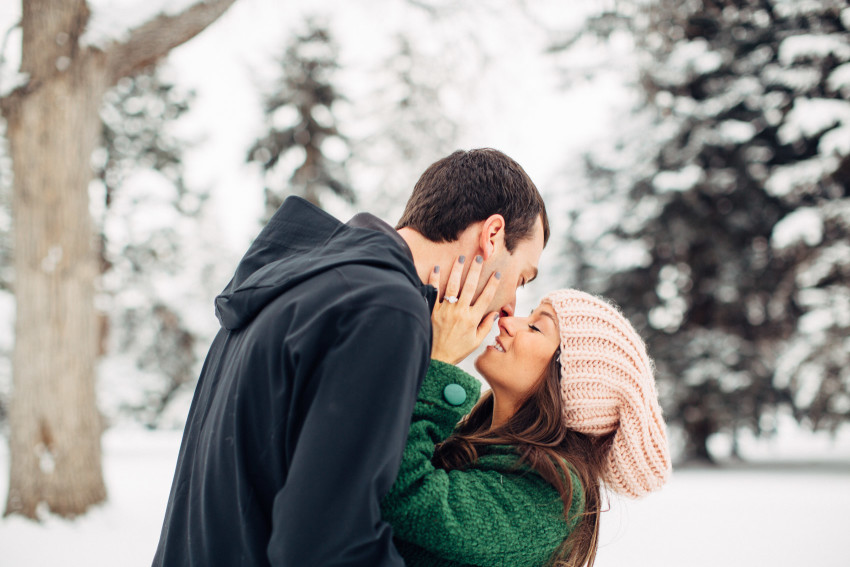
[268,307,431,567]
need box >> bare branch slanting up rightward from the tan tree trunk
[106,0,236,83]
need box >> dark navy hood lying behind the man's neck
[215,197,424,331]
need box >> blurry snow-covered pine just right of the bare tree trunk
[95,68,208,426]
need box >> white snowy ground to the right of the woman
[597,466,850,567]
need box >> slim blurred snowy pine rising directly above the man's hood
[247,19,355,217]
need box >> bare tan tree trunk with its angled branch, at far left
[0,0,235,519]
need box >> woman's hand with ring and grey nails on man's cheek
[428,256,500,364]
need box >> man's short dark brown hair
[396,148,549,252]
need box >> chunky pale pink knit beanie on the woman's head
[543,289,671,498]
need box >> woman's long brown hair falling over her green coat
[433,352,613,567]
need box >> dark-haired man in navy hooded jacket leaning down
[153,149,549,567]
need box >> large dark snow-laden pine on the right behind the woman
[560,0,850,460]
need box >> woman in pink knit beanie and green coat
[382,263,670,567]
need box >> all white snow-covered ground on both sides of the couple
[0,429,850,567]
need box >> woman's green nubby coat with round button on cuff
[382,361,584,567]
